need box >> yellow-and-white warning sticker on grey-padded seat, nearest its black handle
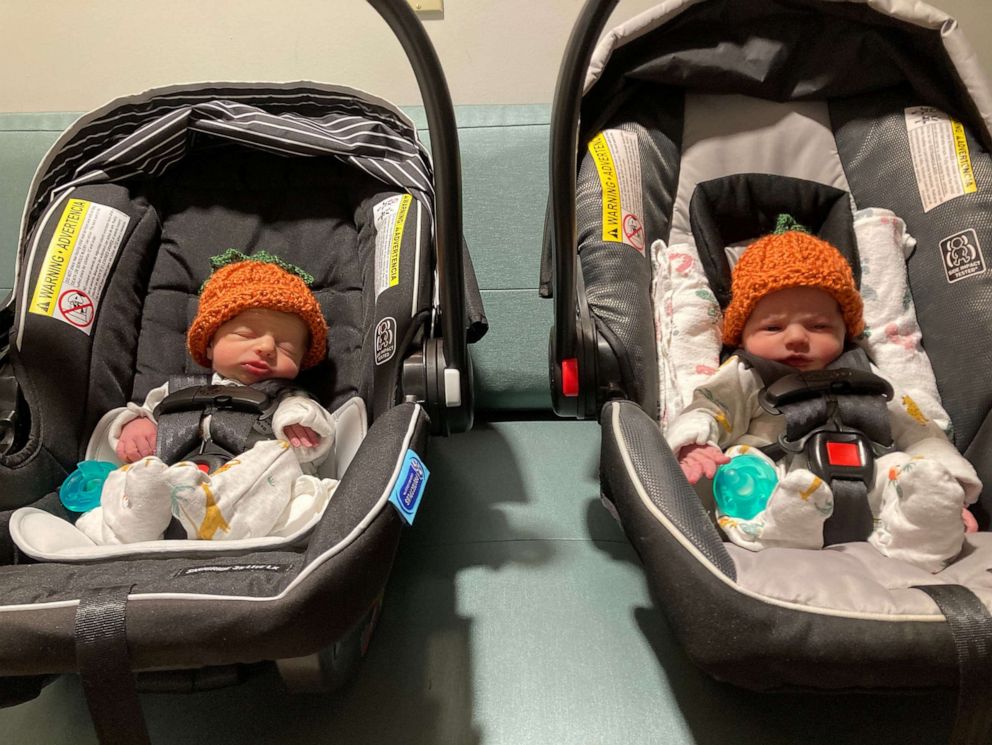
[589,129,644,253]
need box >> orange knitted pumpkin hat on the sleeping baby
[186,248,327,369]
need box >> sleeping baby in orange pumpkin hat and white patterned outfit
[76,251,336,544]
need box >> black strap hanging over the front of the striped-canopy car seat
[75,586,151,745]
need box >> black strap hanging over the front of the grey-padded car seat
[916,585,992,745]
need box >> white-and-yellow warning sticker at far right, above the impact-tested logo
[905,106,978,212]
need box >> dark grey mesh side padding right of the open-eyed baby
[830,89,992,456]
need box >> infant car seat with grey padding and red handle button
[542,0,992,741]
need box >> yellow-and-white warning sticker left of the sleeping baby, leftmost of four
[28,199,130,335]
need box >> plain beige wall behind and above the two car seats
[0,0,992,111]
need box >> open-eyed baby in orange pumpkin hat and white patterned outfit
[666,221,982,572]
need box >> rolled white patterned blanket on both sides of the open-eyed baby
[651,209,951,434]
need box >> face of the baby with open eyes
[741,287,847,370]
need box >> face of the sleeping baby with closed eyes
[207,308,310,385]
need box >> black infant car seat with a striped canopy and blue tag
[0,0,486,742]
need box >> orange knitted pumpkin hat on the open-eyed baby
[723,215,865,346]
